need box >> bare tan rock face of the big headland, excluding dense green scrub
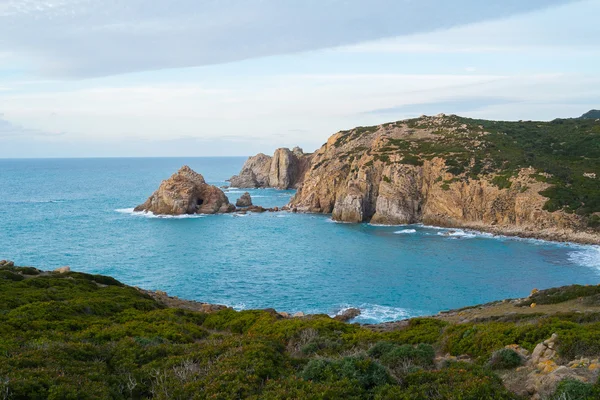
[289,115,600,243]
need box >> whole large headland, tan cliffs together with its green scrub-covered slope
[290,114,600,242]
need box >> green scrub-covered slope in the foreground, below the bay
[0,263,600,399]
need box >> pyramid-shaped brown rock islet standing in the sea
[135,166,235,215]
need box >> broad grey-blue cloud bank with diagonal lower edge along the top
[0,0,574,77]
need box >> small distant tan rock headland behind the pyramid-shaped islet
[229,147,312,189]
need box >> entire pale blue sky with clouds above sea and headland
[0,0,600,158]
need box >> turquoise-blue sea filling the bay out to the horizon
[0,158,600,322]
